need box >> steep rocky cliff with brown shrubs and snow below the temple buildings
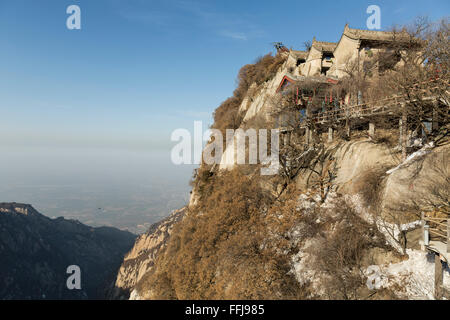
[115,45,450,299]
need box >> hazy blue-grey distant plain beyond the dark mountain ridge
[0,148,193,233]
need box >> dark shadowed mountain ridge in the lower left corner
[0,203,135,299]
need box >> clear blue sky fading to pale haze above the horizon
[0,0,450,230]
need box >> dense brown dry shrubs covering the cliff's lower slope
[138,169,306,299]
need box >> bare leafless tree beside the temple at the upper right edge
[378,18,450,146]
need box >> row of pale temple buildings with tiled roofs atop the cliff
[286,24,411,80]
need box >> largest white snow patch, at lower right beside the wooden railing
[365,249,450,300]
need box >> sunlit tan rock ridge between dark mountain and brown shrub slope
[109,208,187,299]
